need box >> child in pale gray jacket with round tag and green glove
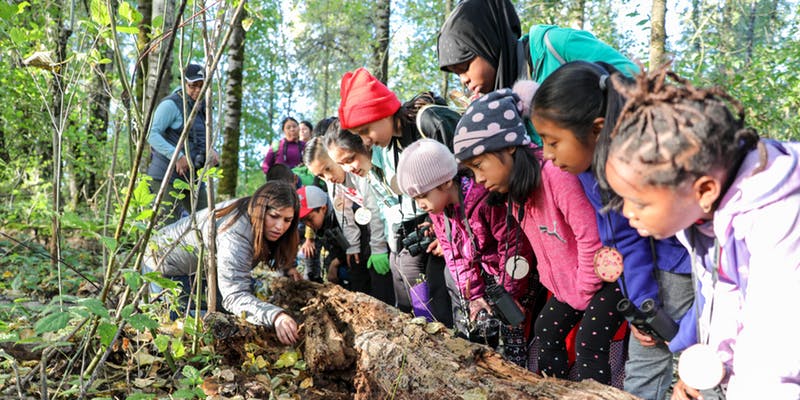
[303,137,394,305]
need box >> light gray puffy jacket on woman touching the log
[144,200,284,327]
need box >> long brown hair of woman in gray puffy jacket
[214,181,300,269]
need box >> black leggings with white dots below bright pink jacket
[534,282,624,384]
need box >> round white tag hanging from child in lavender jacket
[678,344,725,390]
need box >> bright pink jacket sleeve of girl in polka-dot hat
[542,161,602,302]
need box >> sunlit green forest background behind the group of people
[0,0,800,396]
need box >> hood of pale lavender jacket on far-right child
[714,139,800,242]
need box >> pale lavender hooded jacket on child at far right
[682,139,800,400]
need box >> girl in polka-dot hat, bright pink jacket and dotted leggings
[454,82,622,384]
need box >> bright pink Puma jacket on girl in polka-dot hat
[514,159,602,310]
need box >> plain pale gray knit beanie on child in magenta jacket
[397,139,458,197]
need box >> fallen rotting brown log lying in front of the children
[206,279,635,400]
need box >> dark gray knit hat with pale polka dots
[453,83,535,161]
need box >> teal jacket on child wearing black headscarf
[521,25,639,84]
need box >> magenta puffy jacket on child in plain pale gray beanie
[429,178,535,301]
